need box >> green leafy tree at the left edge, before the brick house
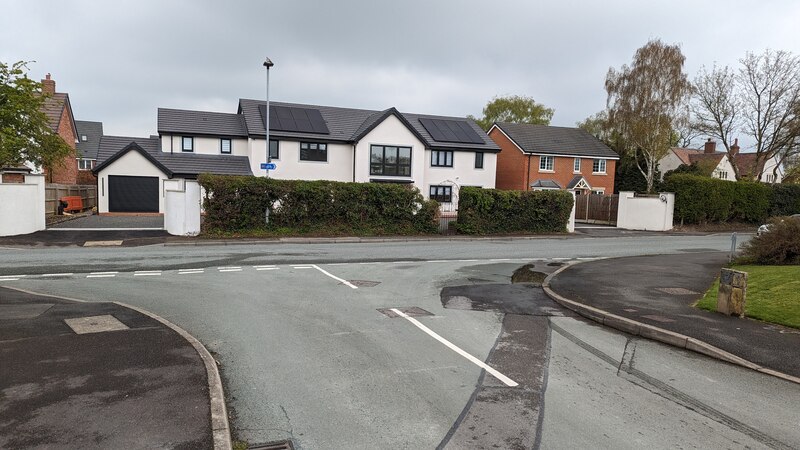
[0,61,72,167]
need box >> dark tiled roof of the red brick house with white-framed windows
[495,122,619,159]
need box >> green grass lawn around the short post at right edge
[697,265,800,328]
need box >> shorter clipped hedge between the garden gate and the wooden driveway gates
[456,187,573,234]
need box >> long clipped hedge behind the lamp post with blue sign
[198,174,439,235]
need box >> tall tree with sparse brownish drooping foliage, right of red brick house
[606,39,691,192]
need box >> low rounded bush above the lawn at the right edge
[739,217,800,265]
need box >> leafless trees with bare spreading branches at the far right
[692,50,800,179]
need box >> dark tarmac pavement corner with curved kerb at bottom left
[0,288,225,449]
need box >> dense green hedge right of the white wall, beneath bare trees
[664,174,775,224]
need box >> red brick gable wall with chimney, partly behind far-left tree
[42,73,78,184]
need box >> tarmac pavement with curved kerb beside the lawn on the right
[545,252,800,383]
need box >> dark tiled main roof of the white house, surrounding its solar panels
[238,99,500,152]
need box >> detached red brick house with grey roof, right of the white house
[489,122,619,194]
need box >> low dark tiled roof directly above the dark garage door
[93,136,253,178]
